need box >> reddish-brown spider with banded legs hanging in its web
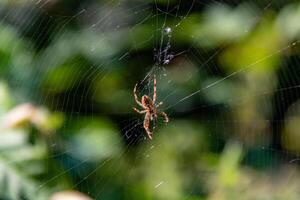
[133,76,169,140]
